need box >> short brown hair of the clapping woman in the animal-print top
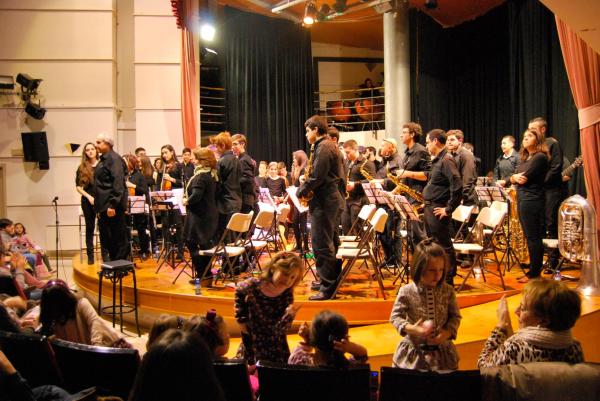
[523,279,581,331]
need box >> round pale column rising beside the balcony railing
[383,0,410,147]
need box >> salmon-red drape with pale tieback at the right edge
[556,17,600,245]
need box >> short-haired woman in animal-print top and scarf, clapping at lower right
[477,279,583,368]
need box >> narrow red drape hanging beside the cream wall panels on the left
[171,0,200,149]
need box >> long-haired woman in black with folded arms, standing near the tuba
[510,130,549,283]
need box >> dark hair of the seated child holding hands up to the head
[310,310,348,368]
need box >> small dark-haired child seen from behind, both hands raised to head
[288,310,369,369]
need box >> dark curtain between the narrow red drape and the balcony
[223,8,312,165]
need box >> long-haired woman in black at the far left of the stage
[75,142,98,265]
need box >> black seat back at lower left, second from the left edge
[51,340,140,399]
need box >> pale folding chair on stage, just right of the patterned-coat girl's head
[453,207,506,292]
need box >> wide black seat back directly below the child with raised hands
[258,362,371,401]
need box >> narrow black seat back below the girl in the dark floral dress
[213,359,254,401]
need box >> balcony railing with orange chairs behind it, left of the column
[314,86,385,131]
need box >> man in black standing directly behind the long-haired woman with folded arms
[528,117,563,270]
